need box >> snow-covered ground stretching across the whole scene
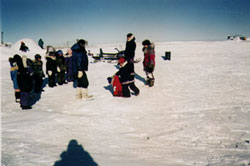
[0,41,250,166]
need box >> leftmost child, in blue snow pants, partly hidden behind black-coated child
[9,57,21,103]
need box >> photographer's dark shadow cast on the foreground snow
[54,139,98,166]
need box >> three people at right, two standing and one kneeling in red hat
[111,33,155,97]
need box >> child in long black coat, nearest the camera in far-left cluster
[14,55,33,109]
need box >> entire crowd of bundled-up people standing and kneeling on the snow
[9,33,155,109]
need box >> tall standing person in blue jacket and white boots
[71,39,93,99]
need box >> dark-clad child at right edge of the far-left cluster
[32,54,45,93]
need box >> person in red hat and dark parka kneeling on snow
[115,58,140,97]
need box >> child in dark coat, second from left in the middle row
[56,50,66,85]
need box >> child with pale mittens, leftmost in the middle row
[46,51,56,88]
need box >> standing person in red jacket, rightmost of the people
[142,39,155,87]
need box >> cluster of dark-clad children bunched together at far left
[9,54,45,109]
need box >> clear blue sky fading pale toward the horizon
[1,0,250,44]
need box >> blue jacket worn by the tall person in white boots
[71,43,89,75]
